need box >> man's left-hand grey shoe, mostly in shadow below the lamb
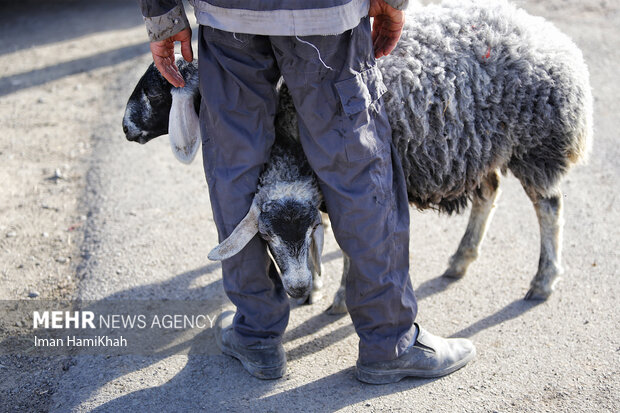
[215,311,286,380]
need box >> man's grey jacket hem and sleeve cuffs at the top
[140,0,409,41]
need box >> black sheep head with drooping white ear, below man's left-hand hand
[123,58,200,163]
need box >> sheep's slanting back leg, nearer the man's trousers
[443,171,501,278]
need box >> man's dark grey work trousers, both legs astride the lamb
[198,18,417,362]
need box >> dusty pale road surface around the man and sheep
[0,0,620,412]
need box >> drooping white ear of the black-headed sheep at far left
[168,88,201,164]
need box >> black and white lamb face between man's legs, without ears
[258,199,323,298]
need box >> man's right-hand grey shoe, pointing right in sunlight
[357,324,476,384]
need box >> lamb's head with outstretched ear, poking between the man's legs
[209,183,323,298]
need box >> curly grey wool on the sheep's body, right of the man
[378,0,592,212]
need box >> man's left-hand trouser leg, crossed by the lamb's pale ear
[198,26,289,346]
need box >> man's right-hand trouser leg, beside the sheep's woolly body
[272,19,417,361]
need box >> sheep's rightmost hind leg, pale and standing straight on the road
[525,190,564,300]
